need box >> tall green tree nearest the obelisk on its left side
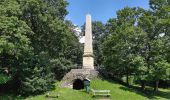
[21,0,81,79]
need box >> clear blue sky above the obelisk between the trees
[66,0,149,26]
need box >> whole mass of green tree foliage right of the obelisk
[102,0,170,90]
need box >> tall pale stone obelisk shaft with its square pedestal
[83,14,94,69]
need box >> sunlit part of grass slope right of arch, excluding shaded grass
[92,80,147,100]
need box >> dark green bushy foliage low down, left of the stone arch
[19,52,55,95]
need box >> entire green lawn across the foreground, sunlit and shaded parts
[0,79,170,100]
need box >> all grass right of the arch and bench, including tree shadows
[91,79,170,100]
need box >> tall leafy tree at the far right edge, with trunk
[139,0,170,91]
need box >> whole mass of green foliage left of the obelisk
[0,0,80,95]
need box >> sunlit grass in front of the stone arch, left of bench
[26,84,93,100]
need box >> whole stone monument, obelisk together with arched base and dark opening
[61,14,98,89]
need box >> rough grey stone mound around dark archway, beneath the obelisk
[61,69,99,88]
